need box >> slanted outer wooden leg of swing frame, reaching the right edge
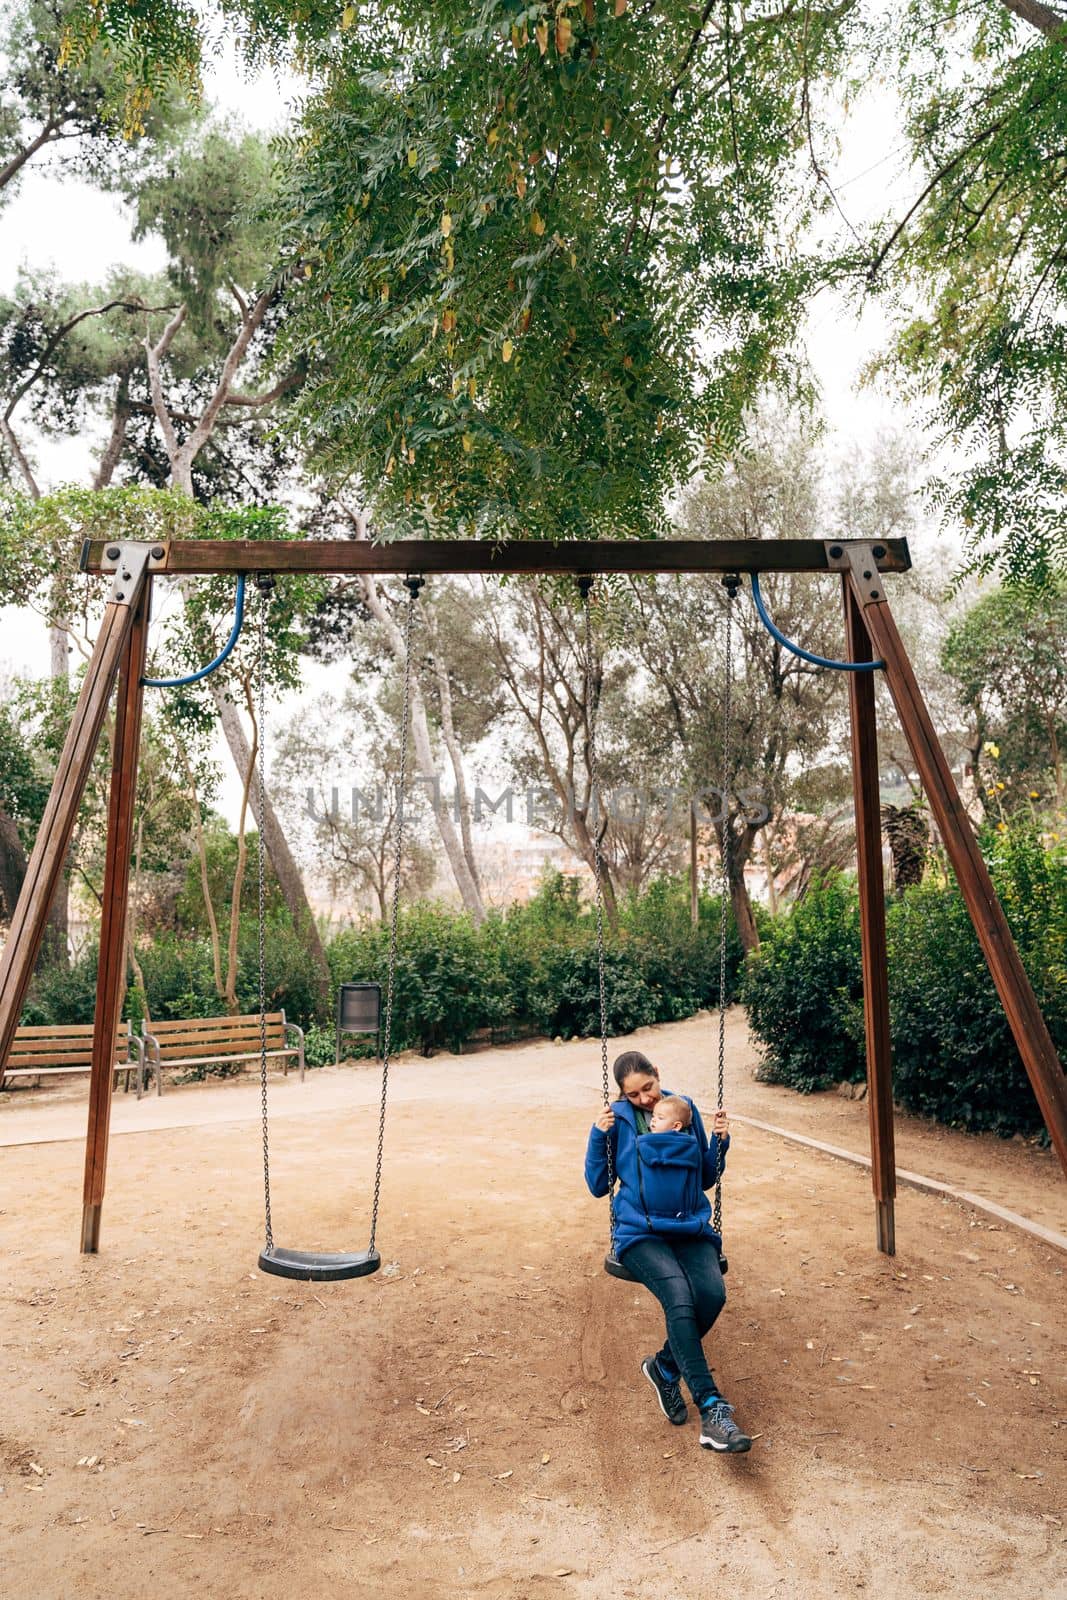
[848,570,1067,1173]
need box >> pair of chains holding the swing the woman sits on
[577,573,741,1283]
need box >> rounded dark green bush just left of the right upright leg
[742,874,865,1094]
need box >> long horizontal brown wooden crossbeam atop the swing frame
[82,539,912,576]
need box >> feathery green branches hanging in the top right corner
[869,0,1067,586]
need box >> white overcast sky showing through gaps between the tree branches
[0,34,918,821]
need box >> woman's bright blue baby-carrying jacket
[585,1090,729,1256]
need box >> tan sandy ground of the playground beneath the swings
[0,1018,1067,1600]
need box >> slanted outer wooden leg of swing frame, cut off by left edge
[0,563,146,1083]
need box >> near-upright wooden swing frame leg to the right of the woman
[841,578,896,1256]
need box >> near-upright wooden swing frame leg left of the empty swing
[82,578,152,1254]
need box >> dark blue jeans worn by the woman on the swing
[622,1235,726,1406]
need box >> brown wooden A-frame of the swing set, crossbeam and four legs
[0,539,1067,1254]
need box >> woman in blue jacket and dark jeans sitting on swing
[585,1050,752,1454]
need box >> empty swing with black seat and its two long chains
[256,578,422,1283]
